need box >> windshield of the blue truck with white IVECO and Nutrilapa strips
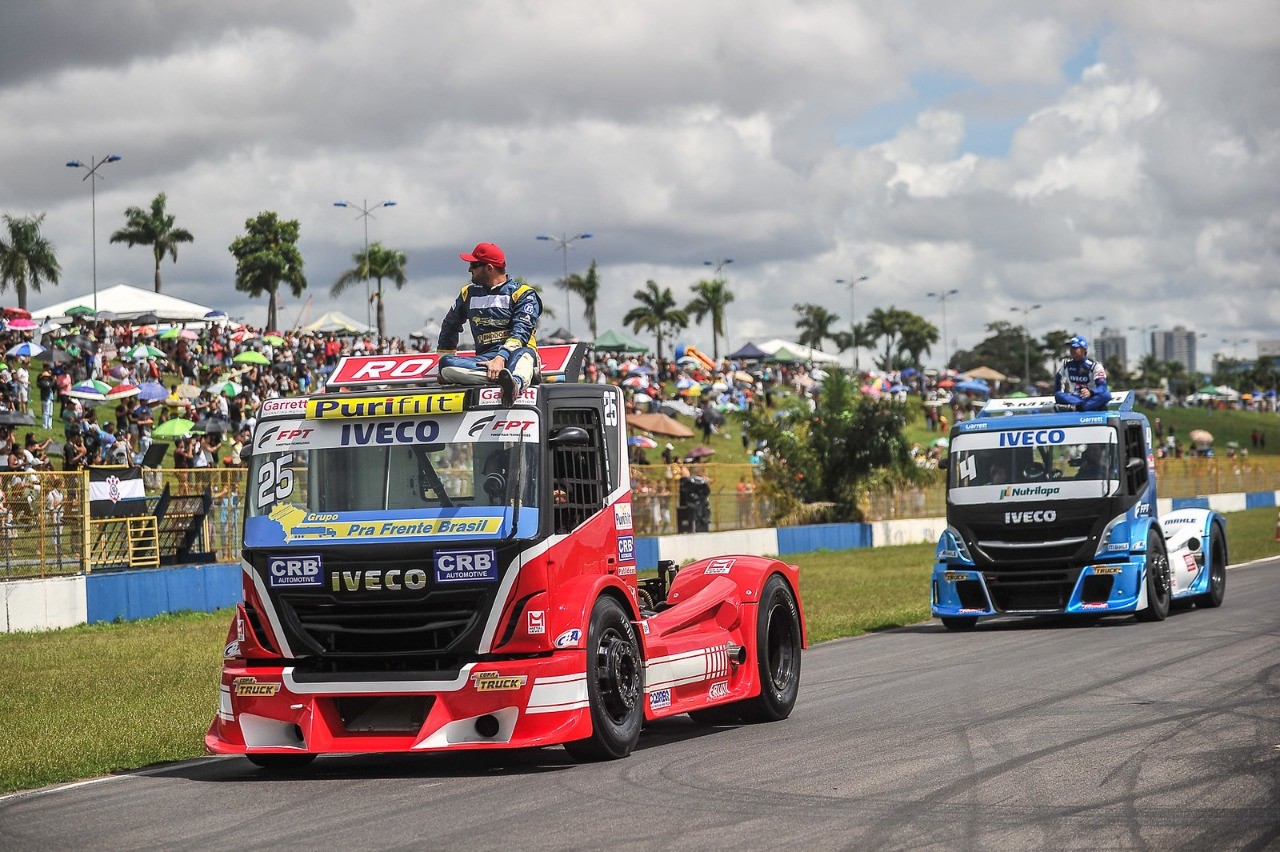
[947,426,1120,503]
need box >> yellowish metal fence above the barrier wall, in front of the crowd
[0,457,1280,580]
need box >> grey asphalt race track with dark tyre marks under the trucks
[0,559,1280,849]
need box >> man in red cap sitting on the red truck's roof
[436,243,543,407]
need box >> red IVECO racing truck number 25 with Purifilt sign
[206,347,806,769]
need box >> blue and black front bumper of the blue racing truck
[932,560,1146,617]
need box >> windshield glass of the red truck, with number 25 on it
[247,440,538,517]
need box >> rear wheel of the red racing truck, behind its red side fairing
[732,574,804,723]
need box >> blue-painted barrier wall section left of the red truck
[84,565,241,624]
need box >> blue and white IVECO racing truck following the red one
[932,391,1228,629]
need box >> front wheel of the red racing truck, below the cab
[564,595,644,762]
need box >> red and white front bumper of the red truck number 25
[205,650,591,753]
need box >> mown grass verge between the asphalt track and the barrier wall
[0,508,1280,793]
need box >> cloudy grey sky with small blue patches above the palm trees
[0,0,1280,368]
